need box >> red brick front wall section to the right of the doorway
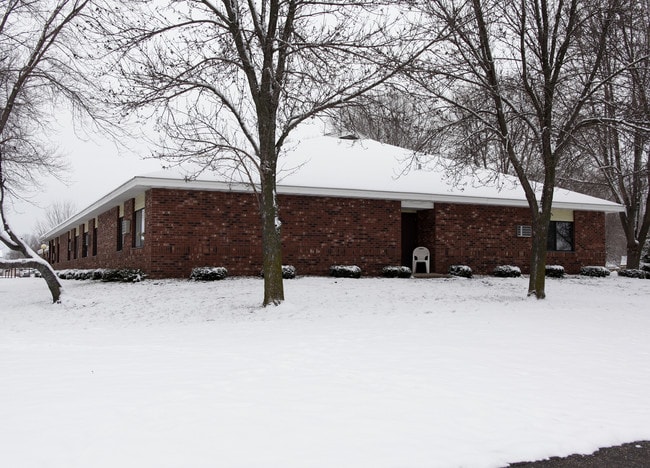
[418,203,605,274]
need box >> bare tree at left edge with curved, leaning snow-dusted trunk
[0,0,90,302]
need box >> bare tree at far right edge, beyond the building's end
[574,0,650,268]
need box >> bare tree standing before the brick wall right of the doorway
[412,0,620,299]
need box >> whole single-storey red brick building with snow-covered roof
[46,136,622,278]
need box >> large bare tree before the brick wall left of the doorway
[95,0,436,305]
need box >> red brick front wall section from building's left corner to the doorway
[145,189,400,277]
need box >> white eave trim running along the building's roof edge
[45,176,625,239]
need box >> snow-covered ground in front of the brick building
[0,275,650,468]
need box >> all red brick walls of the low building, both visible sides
[44,189,605,278]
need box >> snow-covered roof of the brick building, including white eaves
[46,136,624,238]
